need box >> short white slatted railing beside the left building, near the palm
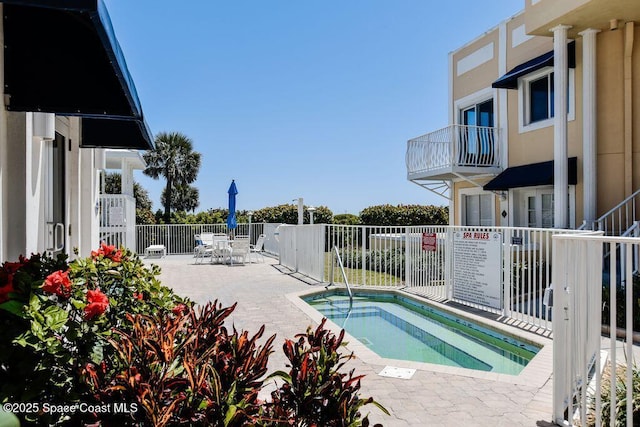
[98,194,136,251]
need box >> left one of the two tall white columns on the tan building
[551,25,571,228]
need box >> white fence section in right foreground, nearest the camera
[553,233,640,426]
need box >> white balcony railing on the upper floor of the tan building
[405,125,500,176]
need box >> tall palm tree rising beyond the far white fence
[143,132,200,221]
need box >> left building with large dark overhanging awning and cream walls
[0,0,153,260]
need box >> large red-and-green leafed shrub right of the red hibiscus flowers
[86,302,275,426]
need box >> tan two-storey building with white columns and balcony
[407,0,640,234]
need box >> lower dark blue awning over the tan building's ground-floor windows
[482,157,578,191]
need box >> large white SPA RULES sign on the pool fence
[453,231,502,309]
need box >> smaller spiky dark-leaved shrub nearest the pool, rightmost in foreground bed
[265,319,388,427]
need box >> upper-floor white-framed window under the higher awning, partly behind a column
[518,67,575,133]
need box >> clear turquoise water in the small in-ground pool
[304,293,540,375]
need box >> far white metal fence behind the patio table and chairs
[135,223,264,255]
